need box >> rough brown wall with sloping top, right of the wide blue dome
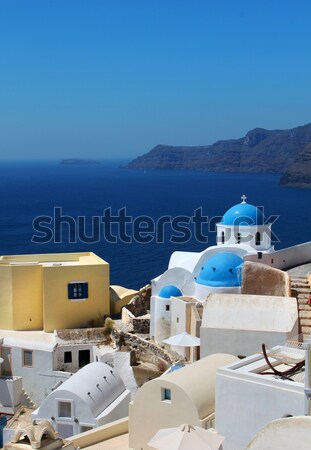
[242,261,291,297]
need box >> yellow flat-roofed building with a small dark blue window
[0,252,109,332]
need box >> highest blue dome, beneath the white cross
[221,202,264,226]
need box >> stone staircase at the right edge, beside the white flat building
[291,277,311,340]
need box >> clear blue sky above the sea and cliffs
[0,0,311,159]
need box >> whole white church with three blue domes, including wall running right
[150,195,311,342]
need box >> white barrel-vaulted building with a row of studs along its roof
[32,362,131,438]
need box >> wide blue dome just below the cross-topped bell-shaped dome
[196,253,243,287]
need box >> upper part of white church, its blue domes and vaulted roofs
[152,195,274,301]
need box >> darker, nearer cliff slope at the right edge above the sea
[280,143,311,188]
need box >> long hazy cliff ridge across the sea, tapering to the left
[127,124,311,179]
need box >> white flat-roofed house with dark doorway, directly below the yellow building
[0,329,113,406]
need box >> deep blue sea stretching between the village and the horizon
[0,161,311,289]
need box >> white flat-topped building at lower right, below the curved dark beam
[215,347,305,450]
